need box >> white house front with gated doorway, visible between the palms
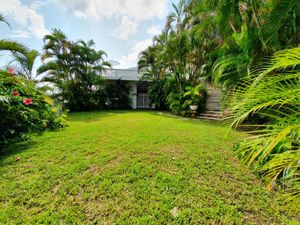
[103,68,154,109]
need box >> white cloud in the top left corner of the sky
[0,0,49,38]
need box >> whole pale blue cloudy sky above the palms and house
[0,0,177,68]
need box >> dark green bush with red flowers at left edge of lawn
[0,68,66,148]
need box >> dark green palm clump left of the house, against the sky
[38,29,110,111]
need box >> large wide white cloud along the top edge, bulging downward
[56,0,168,40]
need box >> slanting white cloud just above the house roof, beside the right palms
[118,39,152,68]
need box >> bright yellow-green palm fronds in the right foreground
[230,47,300,204]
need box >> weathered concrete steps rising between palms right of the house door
[197,85,223,121]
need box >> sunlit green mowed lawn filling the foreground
[0,111,299,224]
